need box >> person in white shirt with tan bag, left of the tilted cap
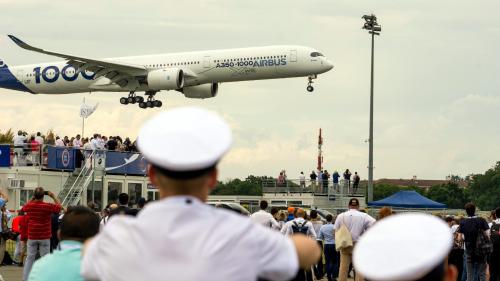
[334,198,375,281]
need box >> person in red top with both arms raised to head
[23,187,62,280]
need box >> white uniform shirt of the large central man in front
[81,196,298,281]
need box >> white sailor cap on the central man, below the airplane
[137,107,232,179]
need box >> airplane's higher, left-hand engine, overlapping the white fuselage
[147,68,184,90]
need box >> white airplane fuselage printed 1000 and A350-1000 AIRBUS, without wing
[0,46,333,94]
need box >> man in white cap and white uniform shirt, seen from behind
[82,107,320,281]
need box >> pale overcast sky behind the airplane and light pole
[0,0,500,179]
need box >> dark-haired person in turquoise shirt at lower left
[29,203,100,281]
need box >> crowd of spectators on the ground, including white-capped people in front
[0,107,500,281]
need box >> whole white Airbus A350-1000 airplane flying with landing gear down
[0,35,333,108]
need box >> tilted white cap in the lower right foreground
[353,213,453,281]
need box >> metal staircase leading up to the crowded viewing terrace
[57,152,95,207]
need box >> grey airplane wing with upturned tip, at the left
[8,35,148,87]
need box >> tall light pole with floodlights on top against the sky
[362,14,382,202]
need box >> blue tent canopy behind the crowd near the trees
[368,191,446,209]
